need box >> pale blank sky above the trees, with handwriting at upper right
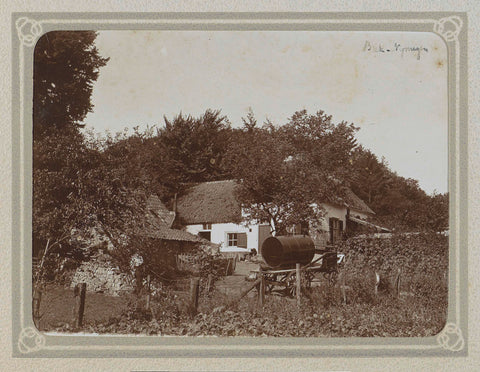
[84,31,448,193]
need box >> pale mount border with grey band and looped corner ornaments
[12,12,468,358]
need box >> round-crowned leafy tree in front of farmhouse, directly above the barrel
[227,110,355,234]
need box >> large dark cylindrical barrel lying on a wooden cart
[261,235,315,268]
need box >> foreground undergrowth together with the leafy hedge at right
[39,234,448,337]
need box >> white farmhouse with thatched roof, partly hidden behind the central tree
[176,180,374,252]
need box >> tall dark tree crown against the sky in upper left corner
[33,31,108,139]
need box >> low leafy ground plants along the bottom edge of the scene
[70,297,445,337]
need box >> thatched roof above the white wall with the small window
[177,180,241,224]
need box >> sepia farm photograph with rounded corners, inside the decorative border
[31,30,449,338]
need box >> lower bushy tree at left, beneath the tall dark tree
[33,133,152,277]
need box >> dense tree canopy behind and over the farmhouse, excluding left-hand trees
[85,110,448,233]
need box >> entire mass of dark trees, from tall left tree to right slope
[33,32,448,282]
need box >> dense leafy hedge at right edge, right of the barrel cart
[338,233,448,305]
